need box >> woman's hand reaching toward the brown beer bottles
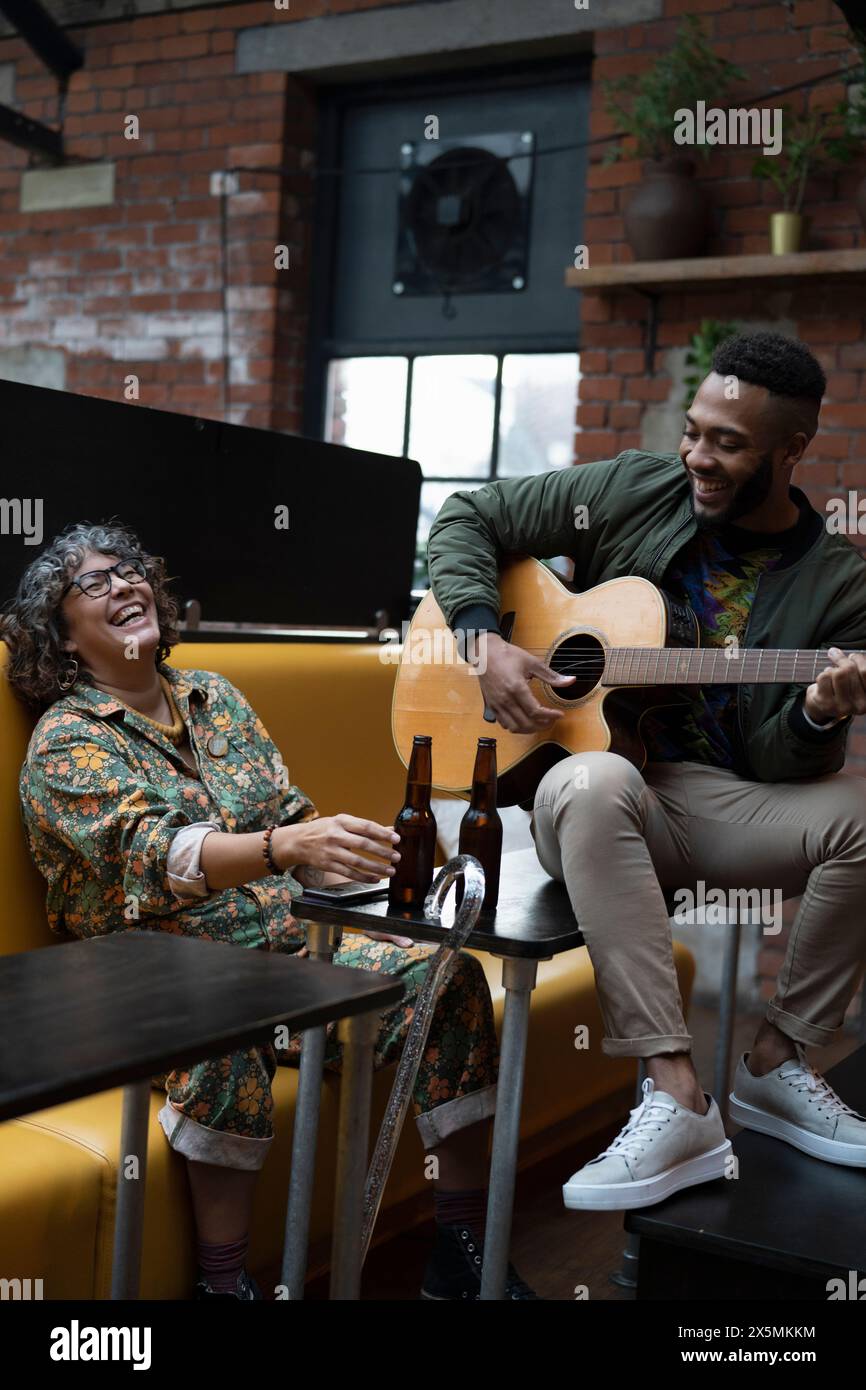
[271,812,400,883]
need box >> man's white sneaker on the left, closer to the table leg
[563,1077,731,1211]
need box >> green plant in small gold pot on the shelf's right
[752,106,855,256]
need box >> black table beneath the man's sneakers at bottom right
[626,1047,866,1301]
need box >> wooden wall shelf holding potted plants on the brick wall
[566,246,866,293]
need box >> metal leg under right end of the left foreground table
[331,1013,381,1300]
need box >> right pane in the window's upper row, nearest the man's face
[496,352,580,478]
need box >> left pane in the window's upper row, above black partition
[325,357,409,455]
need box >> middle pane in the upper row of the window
[409,354,496,478]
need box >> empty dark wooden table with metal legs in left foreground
[0,931,403,1298]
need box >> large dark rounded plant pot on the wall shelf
[624,154,710,260]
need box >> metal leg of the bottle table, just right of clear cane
[481,956,538,1300]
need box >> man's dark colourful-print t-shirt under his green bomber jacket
[641,507,820,767]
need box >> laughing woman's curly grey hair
[0,521,181,713]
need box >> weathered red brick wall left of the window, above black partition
[0,0,326,430]
